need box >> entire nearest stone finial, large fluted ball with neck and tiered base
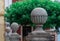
[26,8,53,41]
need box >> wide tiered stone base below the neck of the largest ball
[26,28,52,41]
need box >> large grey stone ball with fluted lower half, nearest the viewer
[31,8,48,24]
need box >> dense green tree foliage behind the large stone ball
[5,0,60,28]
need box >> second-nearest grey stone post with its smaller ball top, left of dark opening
[9,22,20,41]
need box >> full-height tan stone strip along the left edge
[0,0,5,41]
